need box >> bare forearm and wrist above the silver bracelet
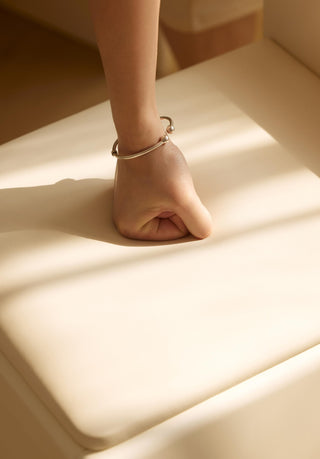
[91,0,163,152]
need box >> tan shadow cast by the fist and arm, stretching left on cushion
[0,179,190,250]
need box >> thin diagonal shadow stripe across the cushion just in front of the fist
[0,208,320,305]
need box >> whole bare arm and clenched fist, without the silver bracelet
[90,0,212,241]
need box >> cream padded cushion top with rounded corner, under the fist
[0,41,320,449]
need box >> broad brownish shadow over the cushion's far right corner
[210,41,320,176]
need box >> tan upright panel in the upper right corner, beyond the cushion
[264,0,320,76]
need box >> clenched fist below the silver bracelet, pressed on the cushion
[113,136,212,241]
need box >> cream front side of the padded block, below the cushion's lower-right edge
[85,346,320,459]
